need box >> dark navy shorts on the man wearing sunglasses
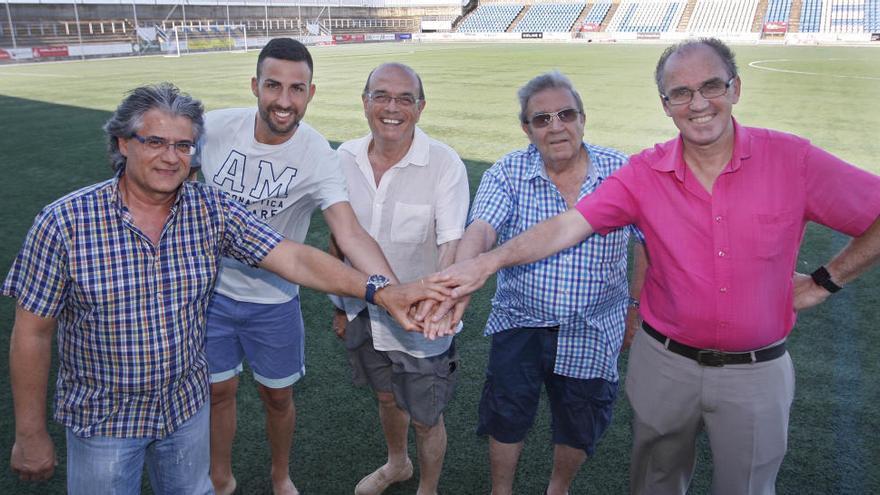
[477,328,618,456]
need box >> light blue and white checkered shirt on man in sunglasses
[470,143,641,381]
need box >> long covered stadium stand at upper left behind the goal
[0,0,450,52]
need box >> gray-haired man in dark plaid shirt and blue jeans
[0,83,446,494]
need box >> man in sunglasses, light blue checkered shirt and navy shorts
[440,72,646,495]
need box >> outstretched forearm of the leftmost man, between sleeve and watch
[260,240,367,298]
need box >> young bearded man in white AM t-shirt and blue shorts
[202,38,396,494]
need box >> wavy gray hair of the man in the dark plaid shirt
[104,82,205,172]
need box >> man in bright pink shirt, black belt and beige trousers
[438,39,880,494]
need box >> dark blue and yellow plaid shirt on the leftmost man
[0,178,281,438]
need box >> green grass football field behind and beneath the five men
[0,44,880,495]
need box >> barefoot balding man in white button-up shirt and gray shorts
[334,63,469,495]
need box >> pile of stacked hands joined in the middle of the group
[333,257,494,340]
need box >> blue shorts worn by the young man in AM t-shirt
[206,293,306,388]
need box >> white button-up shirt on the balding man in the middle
[339,128,470,357]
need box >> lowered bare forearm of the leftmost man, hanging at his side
[9,307,55,437]
